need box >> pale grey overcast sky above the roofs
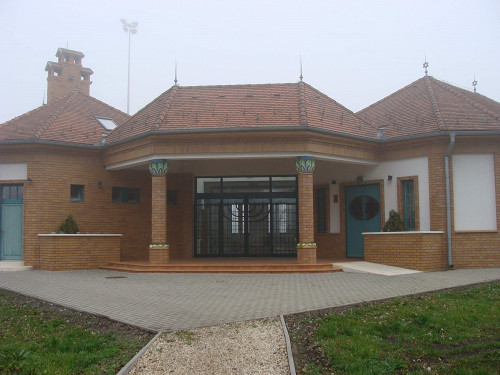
[0,0,500,123]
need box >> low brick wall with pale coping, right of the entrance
[363,232,447,271]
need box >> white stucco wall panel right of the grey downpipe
[452,154,497,230]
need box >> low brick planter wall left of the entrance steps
[38,234,122,271]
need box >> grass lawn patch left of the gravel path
[0,291,152,374]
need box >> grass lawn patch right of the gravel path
[287,282,500,375]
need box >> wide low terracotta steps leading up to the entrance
[100,258,342,273]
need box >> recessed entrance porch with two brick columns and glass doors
[108,153,375,272]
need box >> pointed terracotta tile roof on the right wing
[357,76,500,138]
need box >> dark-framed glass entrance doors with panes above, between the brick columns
[195,176,298,257]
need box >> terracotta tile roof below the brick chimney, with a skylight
[0,91,130,144]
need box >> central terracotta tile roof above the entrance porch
[109,82,376,142]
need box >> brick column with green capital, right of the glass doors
[295,156,316,263]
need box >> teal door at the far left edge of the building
[0,185,23,260]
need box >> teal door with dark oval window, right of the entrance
[345,184,380,258]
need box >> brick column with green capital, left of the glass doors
[149,159,170,264]
